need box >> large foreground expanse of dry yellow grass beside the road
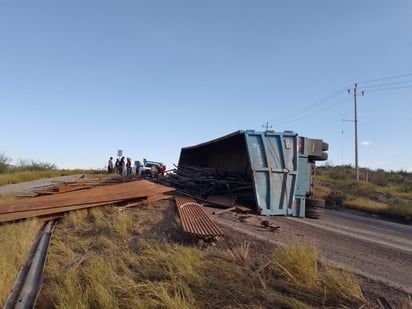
[33,201,368,309]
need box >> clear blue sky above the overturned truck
[0,0,412,171]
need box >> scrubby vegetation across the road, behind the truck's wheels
[314,166,412,224]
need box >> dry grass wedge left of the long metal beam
[0,220,41,304]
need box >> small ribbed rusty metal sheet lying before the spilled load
[175,196,223,239]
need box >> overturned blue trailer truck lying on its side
[178,130,328,218]
